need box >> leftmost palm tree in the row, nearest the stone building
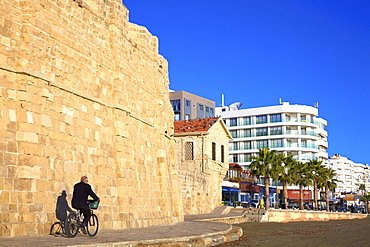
[249,148,277,210]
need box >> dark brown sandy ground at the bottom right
[220,216,370,246]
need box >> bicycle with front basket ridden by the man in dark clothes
[65,200,99,238]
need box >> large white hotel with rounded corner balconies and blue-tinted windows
[216,102,328,169]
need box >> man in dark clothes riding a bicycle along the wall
[72,176,100,229]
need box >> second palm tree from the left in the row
[276,154,297,207]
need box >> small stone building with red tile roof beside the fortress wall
[174,117,232,214]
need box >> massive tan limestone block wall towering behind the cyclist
[0,0,183,236]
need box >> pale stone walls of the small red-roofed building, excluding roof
[176,122,229,214]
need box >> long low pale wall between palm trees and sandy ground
[262,209,367,222]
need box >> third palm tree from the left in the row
[292,161,311,210]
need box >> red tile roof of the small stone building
[174,117,219,133]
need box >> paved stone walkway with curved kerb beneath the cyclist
[0,210,246,247]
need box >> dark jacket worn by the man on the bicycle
[72,182,99,209]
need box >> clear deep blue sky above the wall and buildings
[123,0,370,164]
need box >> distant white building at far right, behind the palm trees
[326,154,370,197]
